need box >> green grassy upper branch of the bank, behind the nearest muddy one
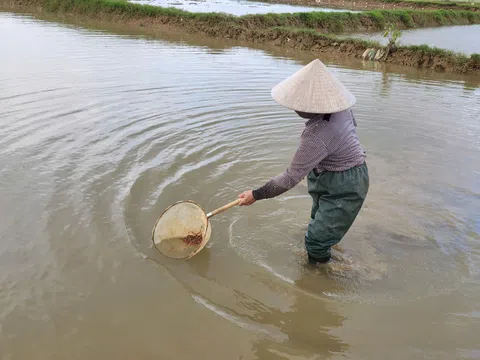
[9,0,480,33]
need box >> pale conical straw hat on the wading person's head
[272,59,356,114]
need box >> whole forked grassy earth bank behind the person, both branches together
[0,0,480,73]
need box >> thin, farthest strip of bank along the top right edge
[256,0,480,11]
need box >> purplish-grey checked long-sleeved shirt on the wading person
[253,110,365,200]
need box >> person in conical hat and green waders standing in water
[239,59,369,264]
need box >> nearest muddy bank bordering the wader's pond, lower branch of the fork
[0,0,480,73]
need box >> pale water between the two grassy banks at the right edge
[355,25,480,55]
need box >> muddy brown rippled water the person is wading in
[0,13,480,360]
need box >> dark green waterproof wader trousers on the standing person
[305,164,369,259]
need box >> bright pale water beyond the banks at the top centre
[129,0,356,16]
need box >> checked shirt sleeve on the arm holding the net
[253,121,328,200]
